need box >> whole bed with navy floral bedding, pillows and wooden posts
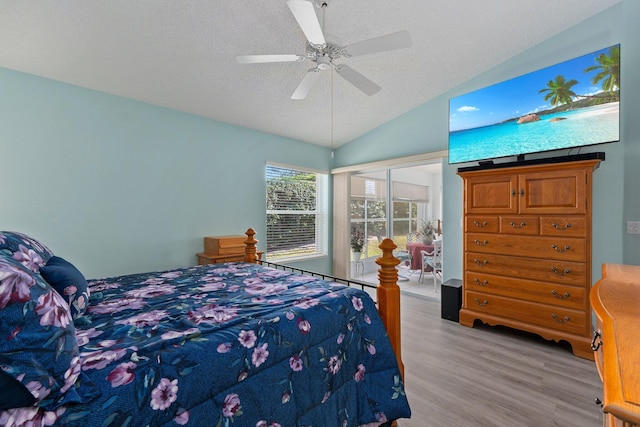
[0,229,410,427]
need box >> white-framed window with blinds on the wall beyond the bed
[266,164,329,261]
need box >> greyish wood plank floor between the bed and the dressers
[399,295,602,427]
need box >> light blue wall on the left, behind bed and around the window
[0,69,331,278]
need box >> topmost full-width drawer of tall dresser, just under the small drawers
[465,233,587,261]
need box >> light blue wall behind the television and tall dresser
[336,0,640,280]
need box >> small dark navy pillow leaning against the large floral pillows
[40,255,89,319]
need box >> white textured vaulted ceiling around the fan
[0,0,620,147]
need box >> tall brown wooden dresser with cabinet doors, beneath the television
[458,160,600,359]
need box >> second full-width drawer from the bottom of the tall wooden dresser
[464,271,587,310]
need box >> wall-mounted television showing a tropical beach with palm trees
[449,44,620,163]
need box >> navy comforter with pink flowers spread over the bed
[5,263,410,427]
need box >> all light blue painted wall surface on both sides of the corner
[0,0,640,279]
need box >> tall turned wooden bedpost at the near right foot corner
[376,238,404,378]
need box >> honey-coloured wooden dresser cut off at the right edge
[590,264,640,427]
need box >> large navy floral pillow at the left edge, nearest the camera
[0,257,86,410]
